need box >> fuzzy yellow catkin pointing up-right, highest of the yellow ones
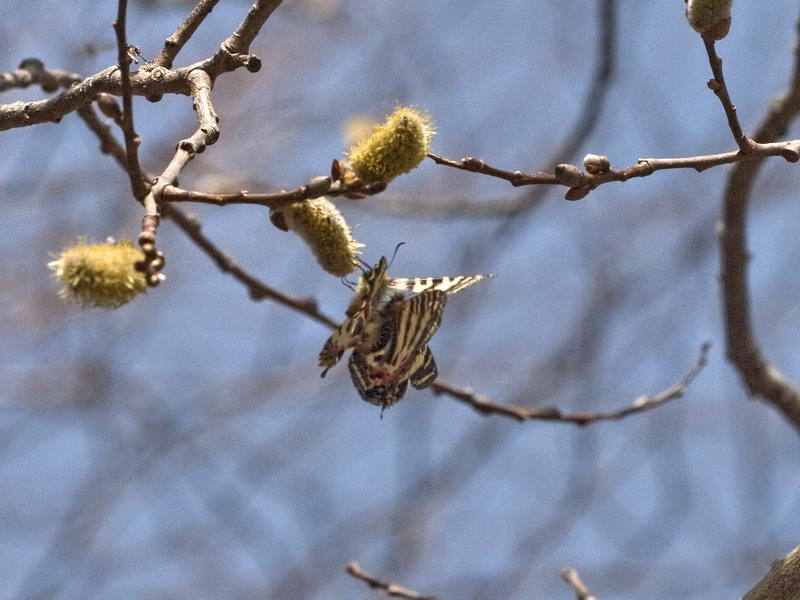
[347,106,435,183]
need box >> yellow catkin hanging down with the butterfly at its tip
[270,198,364,277]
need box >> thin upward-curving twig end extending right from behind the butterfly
[431,343,710,425]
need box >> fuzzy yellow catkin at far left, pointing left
[47,238,147,310]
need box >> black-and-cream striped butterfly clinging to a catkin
[319,257,492,408]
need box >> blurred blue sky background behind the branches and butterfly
[0,0,800,600]
